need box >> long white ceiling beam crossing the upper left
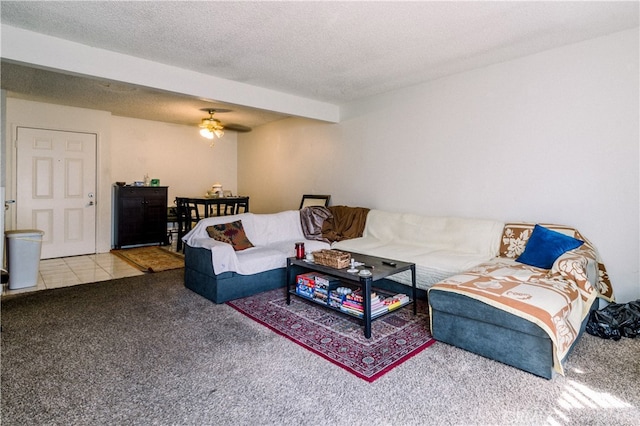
[0,25,340,123]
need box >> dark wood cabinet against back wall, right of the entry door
[113,185,167,249]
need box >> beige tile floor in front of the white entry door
[2,243,176,296]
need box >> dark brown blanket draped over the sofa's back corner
[300,206,369,243]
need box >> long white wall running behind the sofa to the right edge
[238,29,640,301]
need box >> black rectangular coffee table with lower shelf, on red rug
[287,253,417,339]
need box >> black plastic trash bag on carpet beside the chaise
[586,300,640,340]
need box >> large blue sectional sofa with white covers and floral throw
[184,210,613,378]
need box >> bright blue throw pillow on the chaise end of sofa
[516,225,584,269]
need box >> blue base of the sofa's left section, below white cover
[184,244,286,303]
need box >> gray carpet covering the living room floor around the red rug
[0,270,640,425]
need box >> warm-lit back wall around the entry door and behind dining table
[4,98,237,253]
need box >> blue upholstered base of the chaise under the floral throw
[429,289,598,379]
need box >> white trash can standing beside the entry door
[5,229,44,290]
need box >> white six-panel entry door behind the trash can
[16,127,97,259]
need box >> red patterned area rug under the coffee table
[227,289,435,382]
